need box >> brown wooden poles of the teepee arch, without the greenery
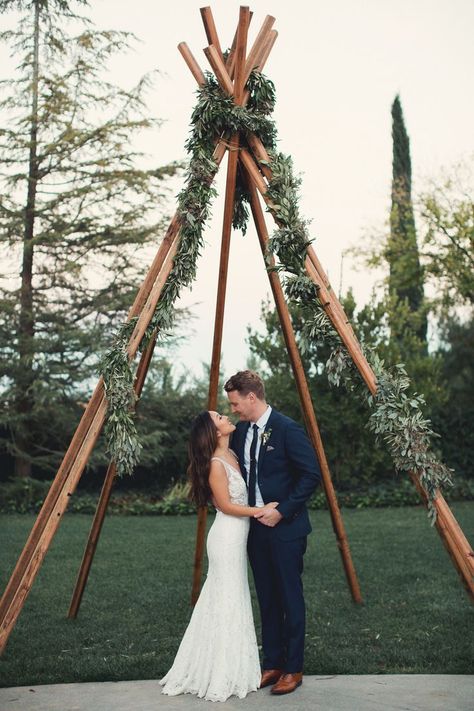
[0,7,474,653]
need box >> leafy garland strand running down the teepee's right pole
[262,153,452,522]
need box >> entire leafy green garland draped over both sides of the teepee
[100,67,452,520]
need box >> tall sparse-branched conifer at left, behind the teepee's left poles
[0,0,176,476]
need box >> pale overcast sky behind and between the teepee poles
[3,0,474,382]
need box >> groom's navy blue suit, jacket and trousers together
[231,409,321,673]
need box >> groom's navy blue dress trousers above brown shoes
[247,519,306,674]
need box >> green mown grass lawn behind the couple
[0,502,474,686]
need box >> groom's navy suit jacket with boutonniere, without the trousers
[231,409,321,540]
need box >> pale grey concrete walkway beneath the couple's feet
[0,674,474,711]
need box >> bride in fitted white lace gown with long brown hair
[160,411,277,701]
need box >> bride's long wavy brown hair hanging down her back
[188,410,217,506]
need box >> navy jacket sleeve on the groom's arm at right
[277,422,321,518]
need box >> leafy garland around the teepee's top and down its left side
[99,73,275,476]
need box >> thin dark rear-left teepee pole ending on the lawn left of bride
[68,336,156,619]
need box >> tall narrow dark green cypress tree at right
[386,95,427,350]
